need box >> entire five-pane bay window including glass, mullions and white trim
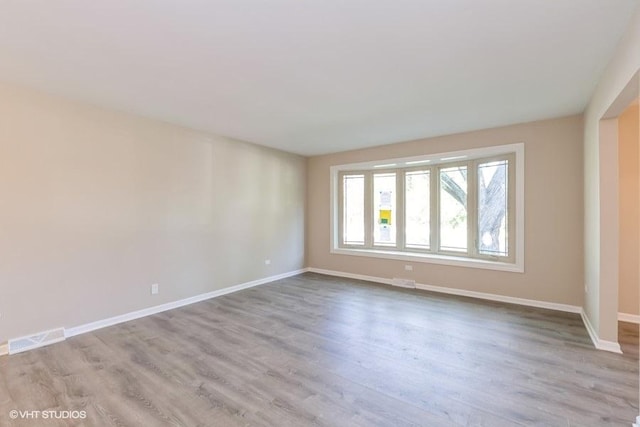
[332,144,524,271]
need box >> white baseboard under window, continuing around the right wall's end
[307,267,622,353]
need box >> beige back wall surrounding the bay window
[307,116,583,306]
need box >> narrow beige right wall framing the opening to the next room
[584,7,640,342]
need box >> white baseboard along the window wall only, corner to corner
[308,268,582,313]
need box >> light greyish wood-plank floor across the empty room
[0,273,638,427]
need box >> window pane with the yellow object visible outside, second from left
[373,173,396,246]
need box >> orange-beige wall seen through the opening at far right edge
[618,104,640,314]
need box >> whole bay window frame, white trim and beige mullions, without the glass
[330,143,524,272]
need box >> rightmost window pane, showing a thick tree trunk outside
[478,160,509,256]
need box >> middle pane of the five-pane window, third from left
[404,170,431,249]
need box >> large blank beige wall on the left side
[0,85,306,343]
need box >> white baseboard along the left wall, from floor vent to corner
[65,268,307,338]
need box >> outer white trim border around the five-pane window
[329,143,525,273]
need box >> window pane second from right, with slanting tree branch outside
[440,166,467,252]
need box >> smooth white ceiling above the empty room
[0,0,638,155]
